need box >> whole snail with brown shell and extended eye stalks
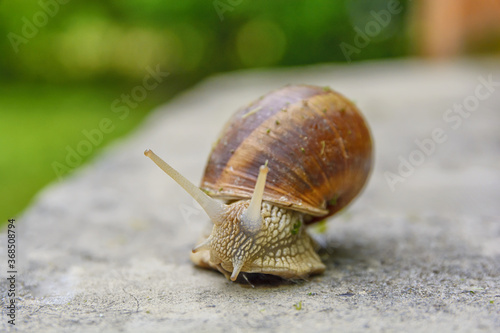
[144,85,372,281]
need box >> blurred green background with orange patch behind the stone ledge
[0,0,500,223]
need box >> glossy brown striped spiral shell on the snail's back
[201,85,372,222]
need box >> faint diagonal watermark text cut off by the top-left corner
[7,0,71,53]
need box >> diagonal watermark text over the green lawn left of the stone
[52,65,170,180]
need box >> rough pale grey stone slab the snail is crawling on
[0,60,500,332]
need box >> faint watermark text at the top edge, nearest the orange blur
[339,0,403,63]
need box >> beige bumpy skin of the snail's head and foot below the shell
[191,200,325,279]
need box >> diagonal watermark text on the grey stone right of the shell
[384,74,500,192]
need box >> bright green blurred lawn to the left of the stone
[0,82,173,226]
